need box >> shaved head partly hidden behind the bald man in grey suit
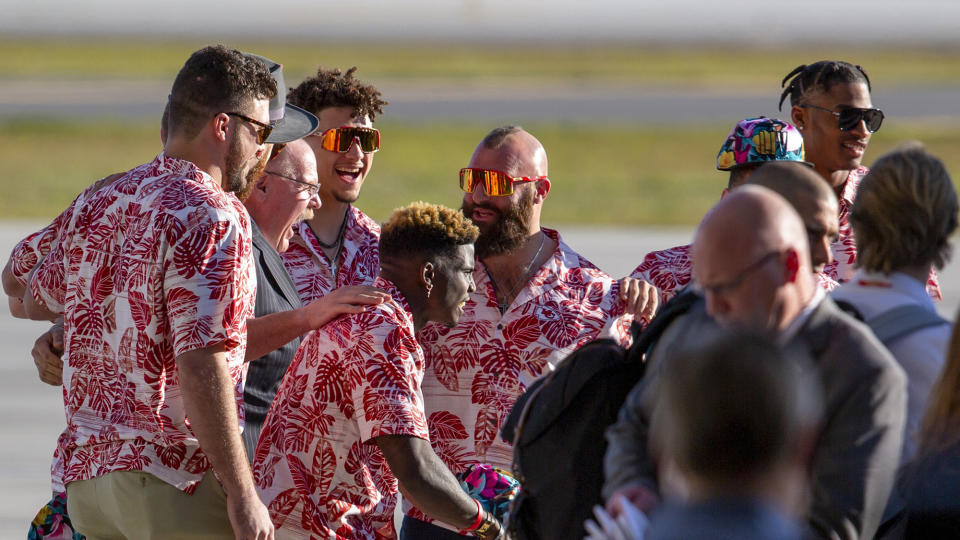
[747,161,840,272]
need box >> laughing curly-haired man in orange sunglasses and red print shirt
[283,67,387,303]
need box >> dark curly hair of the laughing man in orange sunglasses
[287,66,388,122]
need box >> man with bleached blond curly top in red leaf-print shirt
[254,203,500,538]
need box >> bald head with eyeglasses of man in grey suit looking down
[692,185,814,331]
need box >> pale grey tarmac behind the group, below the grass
[0,222,960,538]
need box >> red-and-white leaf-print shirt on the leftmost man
[30,154,256,492]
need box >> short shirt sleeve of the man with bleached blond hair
[353,318,430,441]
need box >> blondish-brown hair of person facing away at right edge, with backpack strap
[850,143,958,274]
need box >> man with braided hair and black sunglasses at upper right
[780,60,943,300]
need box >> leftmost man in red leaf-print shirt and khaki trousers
[24,46,276,538]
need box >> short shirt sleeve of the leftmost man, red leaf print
[163,208,256,356]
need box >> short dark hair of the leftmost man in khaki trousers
[167,45,277,137]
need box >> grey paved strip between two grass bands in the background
[0,78,958,124]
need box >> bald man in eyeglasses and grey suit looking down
[604,185,906,539]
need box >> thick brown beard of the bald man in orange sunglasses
[461,186,533,260]
